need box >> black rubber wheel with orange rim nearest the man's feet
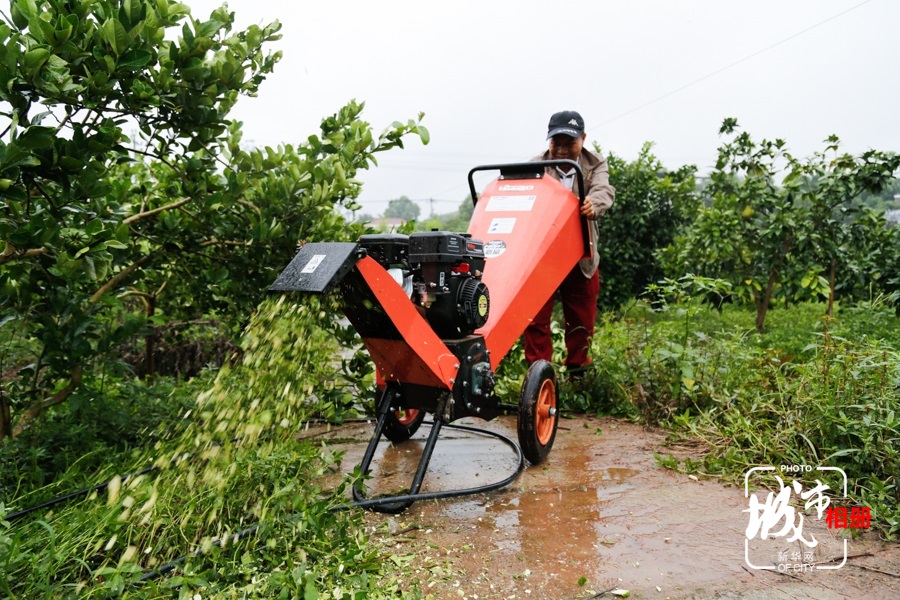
[518,360,559,465]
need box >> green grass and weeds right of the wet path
[576,301,900,539]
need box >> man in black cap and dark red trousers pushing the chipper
[525,110,616,377]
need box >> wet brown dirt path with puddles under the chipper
[316,416,900,600]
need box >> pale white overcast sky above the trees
[185,0,900,216]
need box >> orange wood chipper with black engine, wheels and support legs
[269,160,593,513]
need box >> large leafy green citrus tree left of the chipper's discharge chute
[0,0,427,439]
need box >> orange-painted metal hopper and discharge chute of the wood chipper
[344,170,592,389]
